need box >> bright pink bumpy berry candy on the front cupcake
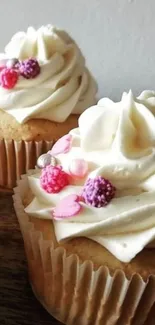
[40,165,69,193]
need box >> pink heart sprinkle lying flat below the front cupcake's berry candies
[53,194,81,220]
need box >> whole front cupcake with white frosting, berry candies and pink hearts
[14,91,155,325]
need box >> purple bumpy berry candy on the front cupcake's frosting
[82,176,116,208]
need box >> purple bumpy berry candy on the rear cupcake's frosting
[16,58,40,79]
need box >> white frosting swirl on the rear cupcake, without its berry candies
[0,25,97,123]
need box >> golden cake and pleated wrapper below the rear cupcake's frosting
[0,111,78,189]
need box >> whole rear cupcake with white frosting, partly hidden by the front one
[0,25,97,189]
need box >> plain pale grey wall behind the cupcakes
[0,0,155,99]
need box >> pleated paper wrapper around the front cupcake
[14,175,155,325]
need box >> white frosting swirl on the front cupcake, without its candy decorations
[26,91,155,262]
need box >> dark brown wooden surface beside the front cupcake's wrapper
[0,193,63,325]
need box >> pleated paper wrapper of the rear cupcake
[0,139,54,189]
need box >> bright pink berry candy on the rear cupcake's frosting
[0,68,18,89]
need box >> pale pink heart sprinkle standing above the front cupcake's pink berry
[50,134,72,156]
